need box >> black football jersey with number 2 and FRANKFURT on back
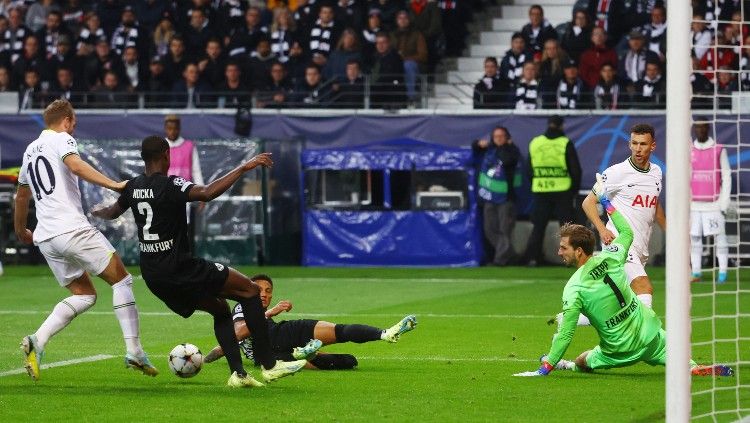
[117,173,193,276]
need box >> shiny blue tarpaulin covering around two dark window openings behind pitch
[302,138,482,266]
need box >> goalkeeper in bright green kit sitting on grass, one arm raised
[514,174,734,376]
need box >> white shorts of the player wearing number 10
[38,227,115,286]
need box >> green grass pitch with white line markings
[0,266,750,422]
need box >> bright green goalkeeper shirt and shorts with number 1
[547,211,661,365]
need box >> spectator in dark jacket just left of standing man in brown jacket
[370,31,404,108]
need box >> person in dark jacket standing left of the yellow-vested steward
[471,126,522,266]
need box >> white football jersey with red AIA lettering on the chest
[602,158,662,264]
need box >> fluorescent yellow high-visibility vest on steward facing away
[529,135,573,193]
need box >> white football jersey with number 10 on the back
[18,129,91,244]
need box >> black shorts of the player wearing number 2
[143,257,229,318]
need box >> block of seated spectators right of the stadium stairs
[474,0,750,110]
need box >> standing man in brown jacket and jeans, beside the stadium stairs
[393,10,428,102]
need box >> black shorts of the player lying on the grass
[232,303,319,361]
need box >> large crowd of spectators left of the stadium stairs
[0,0,481,109]
